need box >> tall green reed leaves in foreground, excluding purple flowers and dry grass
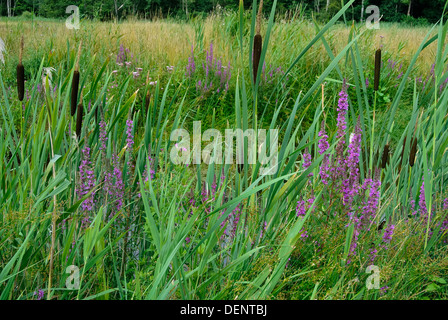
[0,0,448,299]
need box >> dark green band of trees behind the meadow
[0,0,446,24]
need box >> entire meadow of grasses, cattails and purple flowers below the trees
[0,1,448,300]
